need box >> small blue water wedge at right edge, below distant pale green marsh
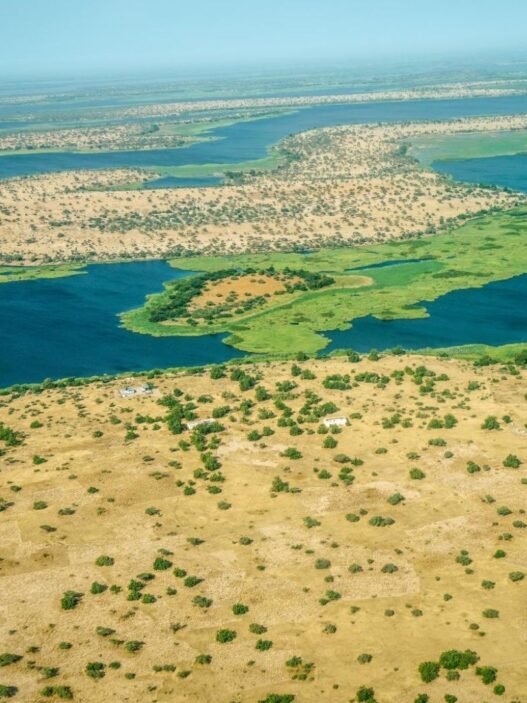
[432,154,527,192]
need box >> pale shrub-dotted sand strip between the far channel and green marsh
[0,117,527,264]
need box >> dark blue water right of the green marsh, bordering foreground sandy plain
[324,274,527,353]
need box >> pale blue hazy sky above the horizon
[0,0,527,76]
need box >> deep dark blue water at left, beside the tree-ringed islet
[0,261,242,387]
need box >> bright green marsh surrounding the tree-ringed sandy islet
[122,208,527,354]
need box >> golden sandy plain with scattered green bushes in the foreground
[0,356,527,703]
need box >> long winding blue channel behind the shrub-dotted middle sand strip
[0,95,527,178]
